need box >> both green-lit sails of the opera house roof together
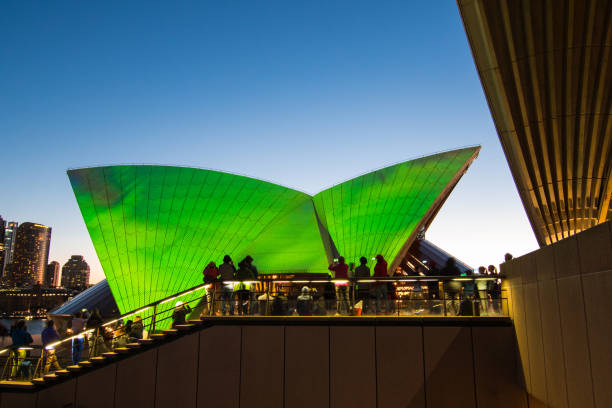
[68,147,480,312]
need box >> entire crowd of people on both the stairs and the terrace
[0,254,512,378]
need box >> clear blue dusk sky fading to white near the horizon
[0,0,537,282]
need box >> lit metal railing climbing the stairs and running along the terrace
[0,275,508,381]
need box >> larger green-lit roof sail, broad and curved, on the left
[68,166,327,311]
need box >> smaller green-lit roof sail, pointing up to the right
[314,147,480,265]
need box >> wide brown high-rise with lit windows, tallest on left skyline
[10,222,51,286]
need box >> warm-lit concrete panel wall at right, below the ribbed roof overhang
[502,222,612,408]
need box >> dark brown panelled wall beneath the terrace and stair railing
[0,319,527,408]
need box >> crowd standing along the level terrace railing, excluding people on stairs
[201,254,504,316]
